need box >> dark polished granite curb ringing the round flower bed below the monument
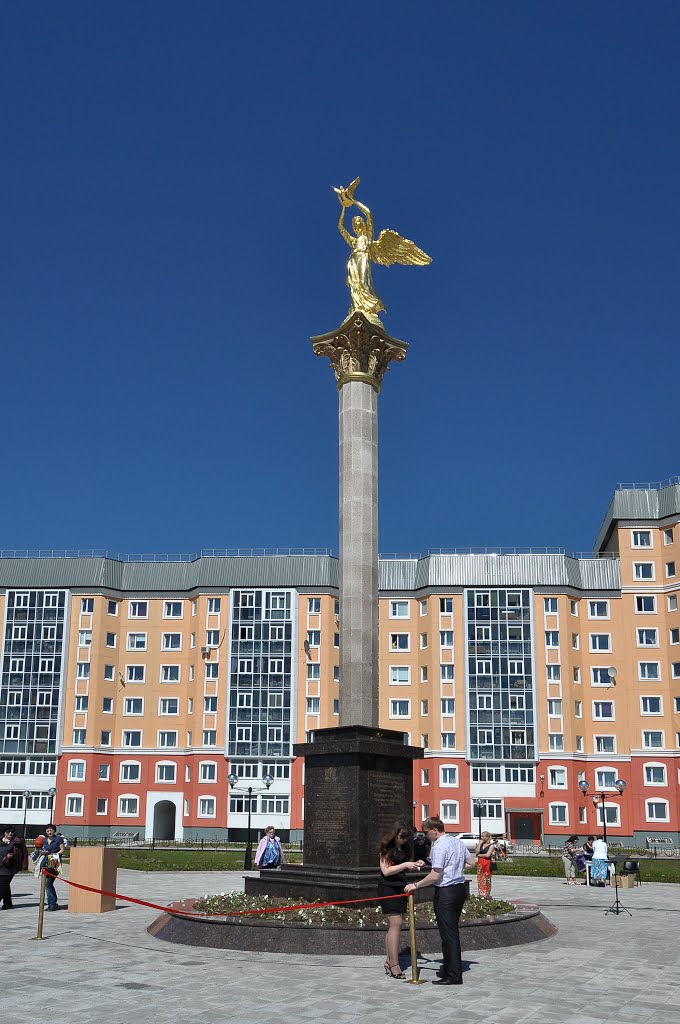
[146,900,557,956]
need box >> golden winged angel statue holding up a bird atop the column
[334,178,432,324]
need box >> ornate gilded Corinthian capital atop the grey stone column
[311,312,409,394]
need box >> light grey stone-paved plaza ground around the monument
[5,870,680,1024]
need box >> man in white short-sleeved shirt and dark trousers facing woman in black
[405,818,477,985]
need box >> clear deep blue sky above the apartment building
[0,0,680,552]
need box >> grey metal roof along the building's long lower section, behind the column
[0,554,621,593]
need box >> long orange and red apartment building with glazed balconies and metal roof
[0,481,680,846]
